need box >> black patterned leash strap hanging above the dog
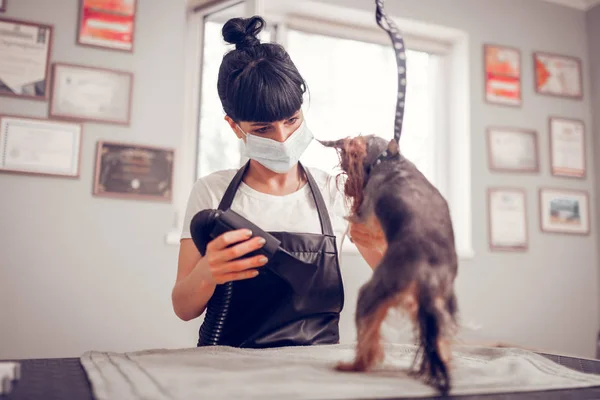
[375,0,406,164]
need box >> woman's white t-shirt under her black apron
[181,167,348,253]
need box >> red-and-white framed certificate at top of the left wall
[77,0,137,52]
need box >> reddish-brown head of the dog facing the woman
[319,135,398,214]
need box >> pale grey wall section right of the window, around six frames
[322,0,599,357]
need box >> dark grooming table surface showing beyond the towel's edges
[0,348,600,400]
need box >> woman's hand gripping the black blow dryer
[198,229,269,284]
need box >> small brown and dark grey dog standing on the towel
[321,135,458,394]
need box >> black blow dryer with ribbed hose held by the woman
[190,209,317,346]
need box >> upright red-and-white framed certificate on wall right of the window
[483,44,522,107]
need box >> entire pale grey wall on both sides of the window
[0,0,598,358]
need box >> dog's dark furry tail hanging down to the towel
[413,274,457,396]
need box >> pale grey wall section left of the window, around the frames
[0,0,194,358]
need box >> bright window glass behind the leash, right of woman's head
[286,30,442,191]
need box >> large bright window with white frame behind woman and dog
[180,0,474,258]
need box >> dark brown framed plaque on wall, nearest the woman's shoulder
[93,141,175,202]
